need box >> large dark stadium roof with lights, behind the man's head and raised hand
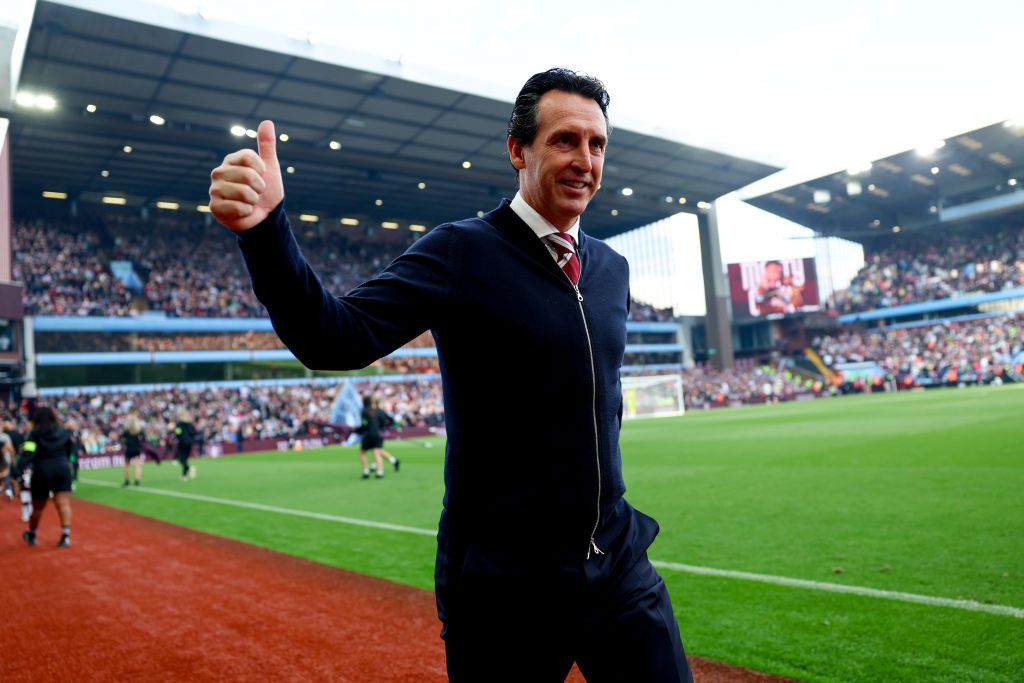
[5,0,777,237]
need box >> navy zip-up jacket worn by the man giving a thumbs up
[239,200,656,583]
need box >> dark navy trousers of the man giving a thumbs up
[442,511,693,683]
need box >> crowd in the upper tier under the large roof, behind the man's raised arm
[14,214,673,325]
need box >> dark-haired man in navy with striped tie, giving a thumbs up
[210,69,692,682]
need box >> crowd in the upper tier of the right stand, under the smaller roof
[831,227,1024,313]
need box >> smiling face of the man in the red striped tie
[508,90,608,230]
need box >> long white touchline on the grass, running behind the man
[81,478,1024,618]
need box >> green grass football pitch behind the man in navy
[78,385,1024,681]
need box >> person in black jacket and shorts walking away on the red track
[18,405,73,548]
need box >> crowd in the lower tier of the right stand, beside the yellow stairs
[813,313,1024,387]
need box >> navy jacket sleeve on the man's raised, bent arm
[239,202,452,370]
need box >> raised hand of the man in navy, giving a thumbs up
[210,121,285,232]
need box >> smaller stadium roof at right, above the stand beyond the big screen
[744,121,1024,242]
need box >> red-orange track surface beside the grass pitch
[0,500,783,683]
